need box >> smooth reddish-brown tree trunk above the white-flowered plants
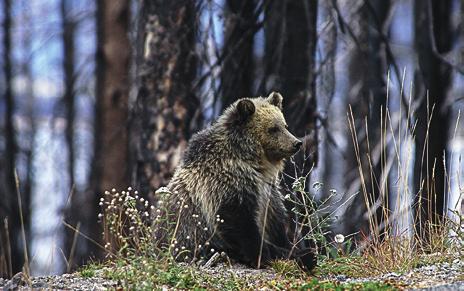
[97,0,131,191]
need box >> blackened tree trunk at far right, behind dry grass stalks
[414,0,452,239]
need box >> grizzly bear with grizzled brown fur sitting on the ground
[159,92,315,269]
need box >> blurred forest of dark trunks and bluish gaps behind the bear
[0,0,464,276]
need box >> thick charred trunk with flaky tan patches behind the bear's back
[130,0,201,194]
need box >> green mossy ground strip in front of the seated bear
[79,257,395,290]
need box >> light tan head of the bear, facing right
[227,92,303,163]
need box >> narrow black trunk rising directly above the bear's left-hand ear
[221,0,257,108]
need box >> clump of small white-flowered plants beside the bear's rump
[98,187,224,261]
